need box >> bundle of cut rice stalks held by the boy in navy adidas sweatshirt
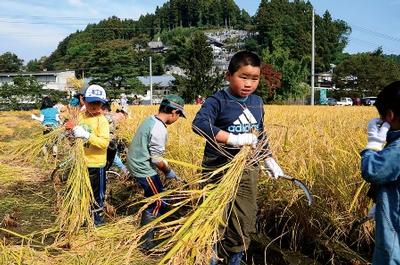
[114,143,260,265]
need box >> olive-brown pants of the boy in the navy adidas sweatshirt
[202,155,259,254]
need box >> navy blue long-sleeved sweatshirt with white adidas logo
[192,89,268,166]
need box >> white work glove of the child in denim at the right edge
[365,118,390,151]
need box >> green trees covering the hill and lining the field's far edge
[0,0,400,107]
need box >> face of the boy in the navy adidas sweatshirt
[226,65,261,97]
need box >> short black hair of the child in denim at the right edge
[375,81,400,119]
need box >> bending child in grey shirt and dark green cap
[127,95,185,250]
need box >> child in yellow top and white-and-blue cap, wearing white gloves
[73,85,110,225]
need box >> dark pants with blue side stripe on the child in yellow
[88,168,106,224]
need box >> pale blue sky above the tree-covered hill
[0,0,400,63]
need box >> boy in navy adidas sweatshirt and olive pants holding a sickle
[193,51,284,265]
